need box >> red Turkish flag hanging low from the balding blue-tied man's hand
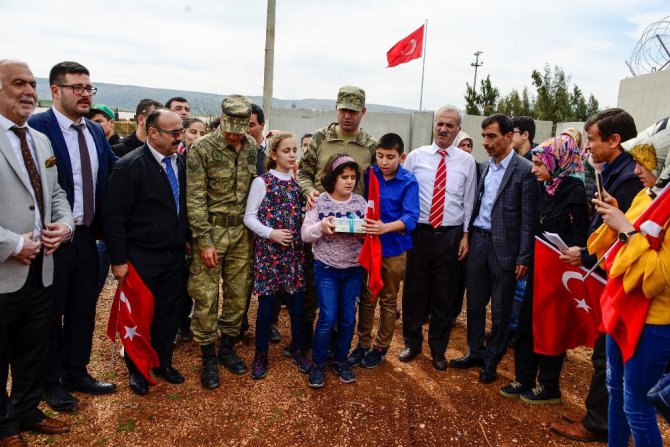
[107,263,160,385]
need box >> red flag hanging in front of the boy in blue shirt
[358,168,384,300]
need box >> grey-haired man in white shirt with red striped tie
[398,106,477,371]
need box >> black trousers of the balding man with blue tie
[128,250,185,368]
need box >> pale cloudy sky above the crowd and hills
[0,0,670,110]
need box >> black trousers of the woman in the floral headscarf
[514,268,565,392]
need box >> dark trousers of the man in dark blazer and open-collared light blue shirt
[466,231,516,367]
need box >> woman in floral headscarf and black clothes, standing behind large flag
[500,128,589,404]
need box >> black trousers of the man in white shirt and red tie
[402,224,463,356]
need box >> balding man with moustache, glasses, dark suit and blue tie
[105,109,189,395]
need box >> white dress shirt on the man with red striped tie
[404,143,477,232]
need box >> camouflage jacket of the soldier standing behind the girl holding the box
[298,123,377,197]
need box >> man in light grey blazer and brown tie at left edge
[0,60,74,446]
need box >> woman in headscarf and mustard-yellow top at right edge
[588,118,670,447]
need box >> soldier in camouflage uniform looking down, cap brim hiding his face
[186,95,256,388]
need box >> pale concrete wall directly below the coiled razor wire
[617,69,670,130]
